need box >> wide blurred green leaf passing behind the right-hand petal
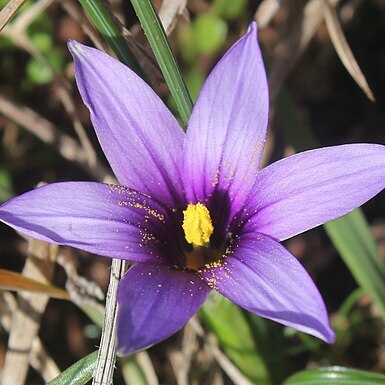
[276,88,385,321]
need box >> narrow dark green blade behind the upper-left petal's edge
[79,0,143,73]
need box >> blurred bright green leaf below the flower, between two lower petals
[200,292,270,385]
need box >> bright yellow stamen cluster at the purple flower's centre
[182,203,214,246]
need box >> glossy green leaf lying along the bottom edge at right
[283,366,385,385]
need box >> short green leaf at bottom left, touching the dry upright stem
[47,351,98,385]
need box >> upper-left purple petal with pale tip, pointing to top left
[68,41,184,204]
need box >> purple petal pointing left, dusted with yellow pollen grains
[0,182,176,263]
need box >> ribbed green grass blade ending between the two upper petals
[131,0,193,126]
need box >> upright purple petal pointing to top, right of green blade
[185,23,269,213]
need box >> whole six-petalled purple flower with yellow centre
[0,24,385,354]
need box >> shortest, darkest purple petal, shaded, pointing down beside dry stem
[117,263,210,355]
